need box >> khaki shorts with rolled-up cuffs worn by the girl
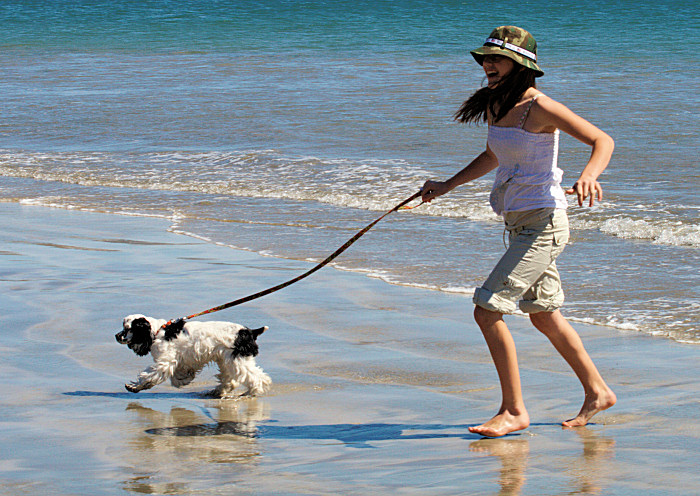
[474,208,569,314]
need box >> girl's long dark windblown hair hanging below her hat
[453,65,536,124]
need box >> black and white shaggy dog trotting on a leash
[114,314,272,398]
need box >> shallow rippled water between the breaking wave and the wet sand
[8,190,700,345]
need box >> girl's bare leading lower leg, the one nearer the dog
[469,306,530,437]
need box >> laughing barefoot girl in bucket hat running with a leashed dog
[422,26,616,436]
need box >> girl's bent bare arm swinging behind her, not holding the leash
[531,95,615,207]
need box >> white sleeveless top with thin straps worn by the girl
[488,95,567,215]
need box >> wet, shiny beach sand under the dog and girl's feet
[0,203,700,496]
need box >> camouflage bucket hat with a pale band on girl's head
[470,26,544,77]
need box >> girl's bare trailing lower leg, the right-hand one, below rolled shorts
[530,310,617,427]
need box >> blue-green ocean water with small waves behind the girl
[0,0,700,344]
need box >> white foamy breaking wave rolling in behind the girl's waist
[8,150,700,247]
